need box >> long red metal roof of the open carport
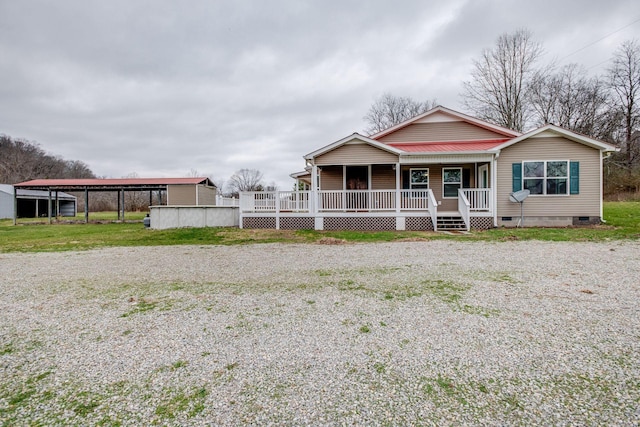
[15,177,211,187]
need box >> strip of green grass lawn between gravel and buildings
[0,202,640,252]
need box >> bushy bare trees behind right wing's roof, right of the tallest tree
[528,64,609,139]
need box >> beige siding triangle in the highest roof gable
[378,121,507,143]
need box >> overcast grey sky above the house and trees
[0,0,640,189]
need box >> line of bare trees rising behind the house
[364,29,640,194]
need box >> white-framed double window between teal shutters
[522,160,569,195]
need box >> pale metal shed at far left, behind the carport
[0,184,78,219]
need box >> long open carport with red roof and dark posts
[13,177,216,224]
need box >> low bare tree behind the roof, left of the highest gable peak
[364,93,437,135]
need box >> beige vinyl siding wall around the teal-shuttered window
[497,137,602,217]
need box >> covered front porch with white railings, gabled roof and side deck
[240,135,496,230]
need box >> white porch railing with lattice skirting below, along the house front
[240,188,493,231]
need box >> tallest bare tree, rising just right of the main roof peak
[462,29,542,131]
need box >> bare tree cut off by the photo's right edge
[609,41,640,171]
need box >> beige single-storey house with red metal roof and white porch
[240,106,616,230]
